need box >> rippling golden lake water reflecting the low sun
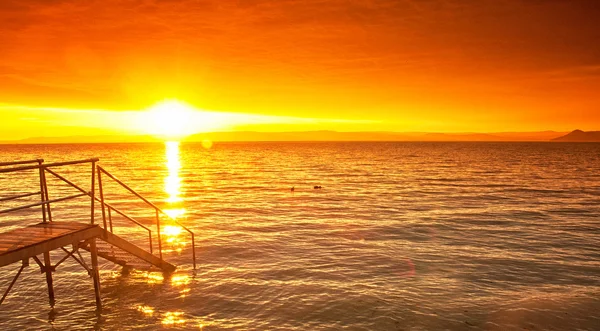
[0,143,600,330]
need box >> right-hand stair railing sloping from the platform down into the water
[97,166,196,269]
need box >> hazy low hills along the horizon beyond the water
[0,130,600,144]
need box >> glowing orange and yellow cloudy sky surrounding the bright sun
[0,0,600,139]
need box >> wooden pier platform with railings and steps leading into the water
[0,159,196,309]
